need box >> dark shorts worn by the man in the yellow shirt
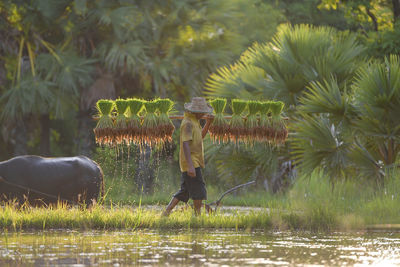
[174,167,207,202]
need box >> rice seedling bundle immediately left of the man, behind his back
[156,98,175,142]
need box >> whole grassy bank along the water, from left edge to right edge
[0,173,400,231]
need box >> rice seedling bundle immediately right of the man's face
[209,98,229,143]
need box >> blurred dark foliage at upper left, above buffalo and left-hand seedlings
[0,0,280,159]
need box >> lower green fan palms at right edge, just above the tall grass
[293,56,400,183]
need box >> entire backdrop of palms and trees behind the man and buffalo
[0,0,400,195]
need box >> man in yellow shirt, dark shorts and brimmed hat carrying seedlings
[163,97,213,216]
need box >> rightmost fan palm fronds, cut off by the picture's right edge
[353,55,400,166]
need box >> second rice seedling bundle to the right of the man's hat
[229,99,247,144]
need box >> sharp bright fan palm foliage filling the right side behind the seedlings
[207,25,400,184]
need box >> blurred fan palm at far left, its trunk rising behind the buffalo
[1,1,95,155]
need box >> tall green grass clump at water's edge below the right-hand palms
[282,172,400,230]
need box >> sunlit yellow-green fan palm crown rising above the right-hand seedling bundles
[206,25,365,106]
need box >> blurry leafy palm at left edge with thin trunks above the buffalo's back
[0,1,96,155]
